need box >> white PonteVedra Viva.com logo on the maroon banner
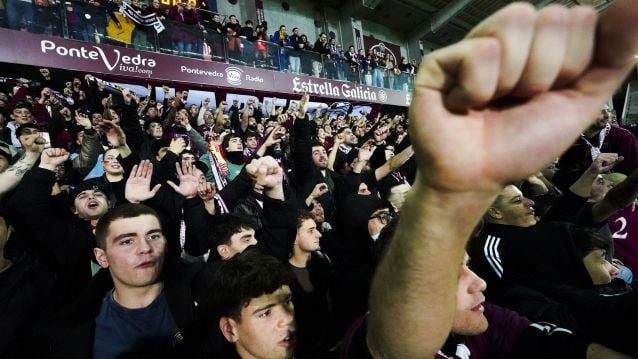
[40,40,157,75]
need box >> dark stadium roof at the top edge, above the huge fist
[324,0,614,46]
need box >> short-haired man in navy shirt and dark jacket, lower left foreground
[44,203,210,358]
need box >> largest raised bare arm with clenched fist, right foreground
[367,0,638,358]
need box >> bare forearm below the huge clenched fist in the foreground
[367,180,497,358]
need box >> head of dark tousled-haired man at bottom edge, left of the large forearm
[211,250,296,359]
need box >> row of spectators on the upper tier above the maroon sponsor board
[2,0,417,91]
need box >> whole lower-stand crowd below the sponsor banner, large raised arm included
[0,0,638,358]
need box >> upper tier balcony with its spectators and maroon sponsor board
[0,1,414,106]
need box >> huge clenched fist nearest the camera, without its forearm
[410,0,638,192]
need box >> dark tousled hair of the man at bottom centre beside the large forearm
[210,249,294,321]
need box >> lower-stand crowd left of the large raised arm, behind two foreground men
[0,69,415,357]
